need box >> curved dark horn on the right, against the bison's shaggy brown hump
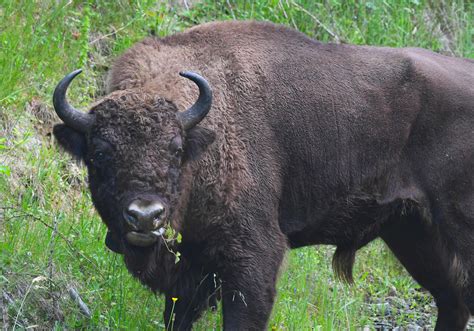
[178,71,212,130]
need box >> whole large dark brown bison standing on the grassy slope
[54,22,474,330]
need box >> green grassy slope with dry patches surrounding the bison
[0,0,474,330]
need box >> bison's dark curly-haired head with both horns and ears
[53,70,214,252]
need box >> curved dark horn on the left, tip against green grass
[53,69,93,133]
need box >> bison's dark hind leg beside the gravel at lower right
[380,213,469,331]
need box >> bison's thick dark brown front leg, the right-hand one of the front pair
[221,233,286,330]
